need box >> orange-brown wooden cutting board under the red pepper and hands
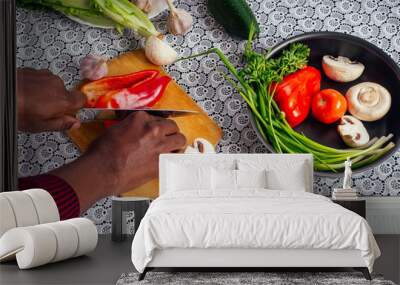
[68,50,222,198]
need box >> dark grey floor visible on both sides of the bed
[0,235,400,285]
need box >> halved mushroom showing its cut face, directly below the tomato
[338,115,369,147]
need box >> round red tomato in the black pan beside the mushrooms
[311,89,347,124]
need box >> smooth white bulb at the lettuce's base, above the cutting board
[144,36,178,65]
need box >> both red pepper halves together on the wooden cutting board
[81,70,171,109]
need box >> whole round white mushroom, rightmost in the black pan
[346,82,392,122]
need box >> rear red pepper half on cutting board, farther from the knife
[81,70,159,107]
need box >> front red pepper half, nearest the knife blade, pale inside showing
[95,76,171,109]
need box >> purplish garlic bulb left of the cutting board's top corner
[80,54,108,80]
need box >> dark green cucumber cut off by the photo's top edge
[207,0,260,39]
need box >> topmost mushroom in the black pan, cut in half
[322,55,364,82]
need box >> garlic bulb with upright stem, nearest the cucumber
[167,0,193,35]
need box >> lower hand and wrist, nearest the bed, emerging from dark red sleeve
[52,112,186,211]
